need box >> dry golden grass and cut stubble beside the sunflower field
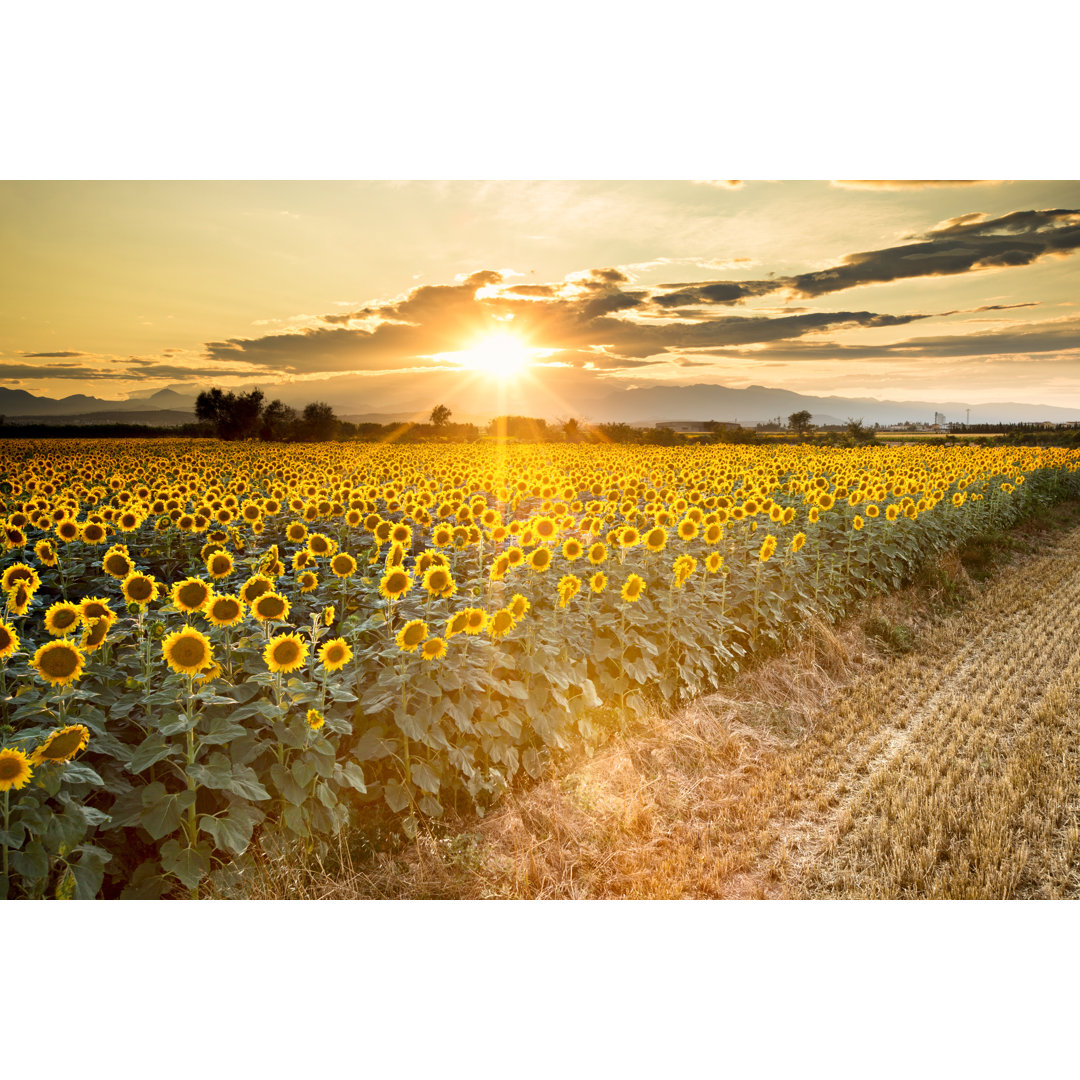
[219,505,1080,899]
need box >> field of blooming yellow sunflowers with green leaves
[0,441,1080,899]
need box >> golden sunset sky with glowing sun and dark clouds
[0,179,1080,416]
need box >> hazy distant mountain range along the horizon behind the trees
[0,383,1080,427]
